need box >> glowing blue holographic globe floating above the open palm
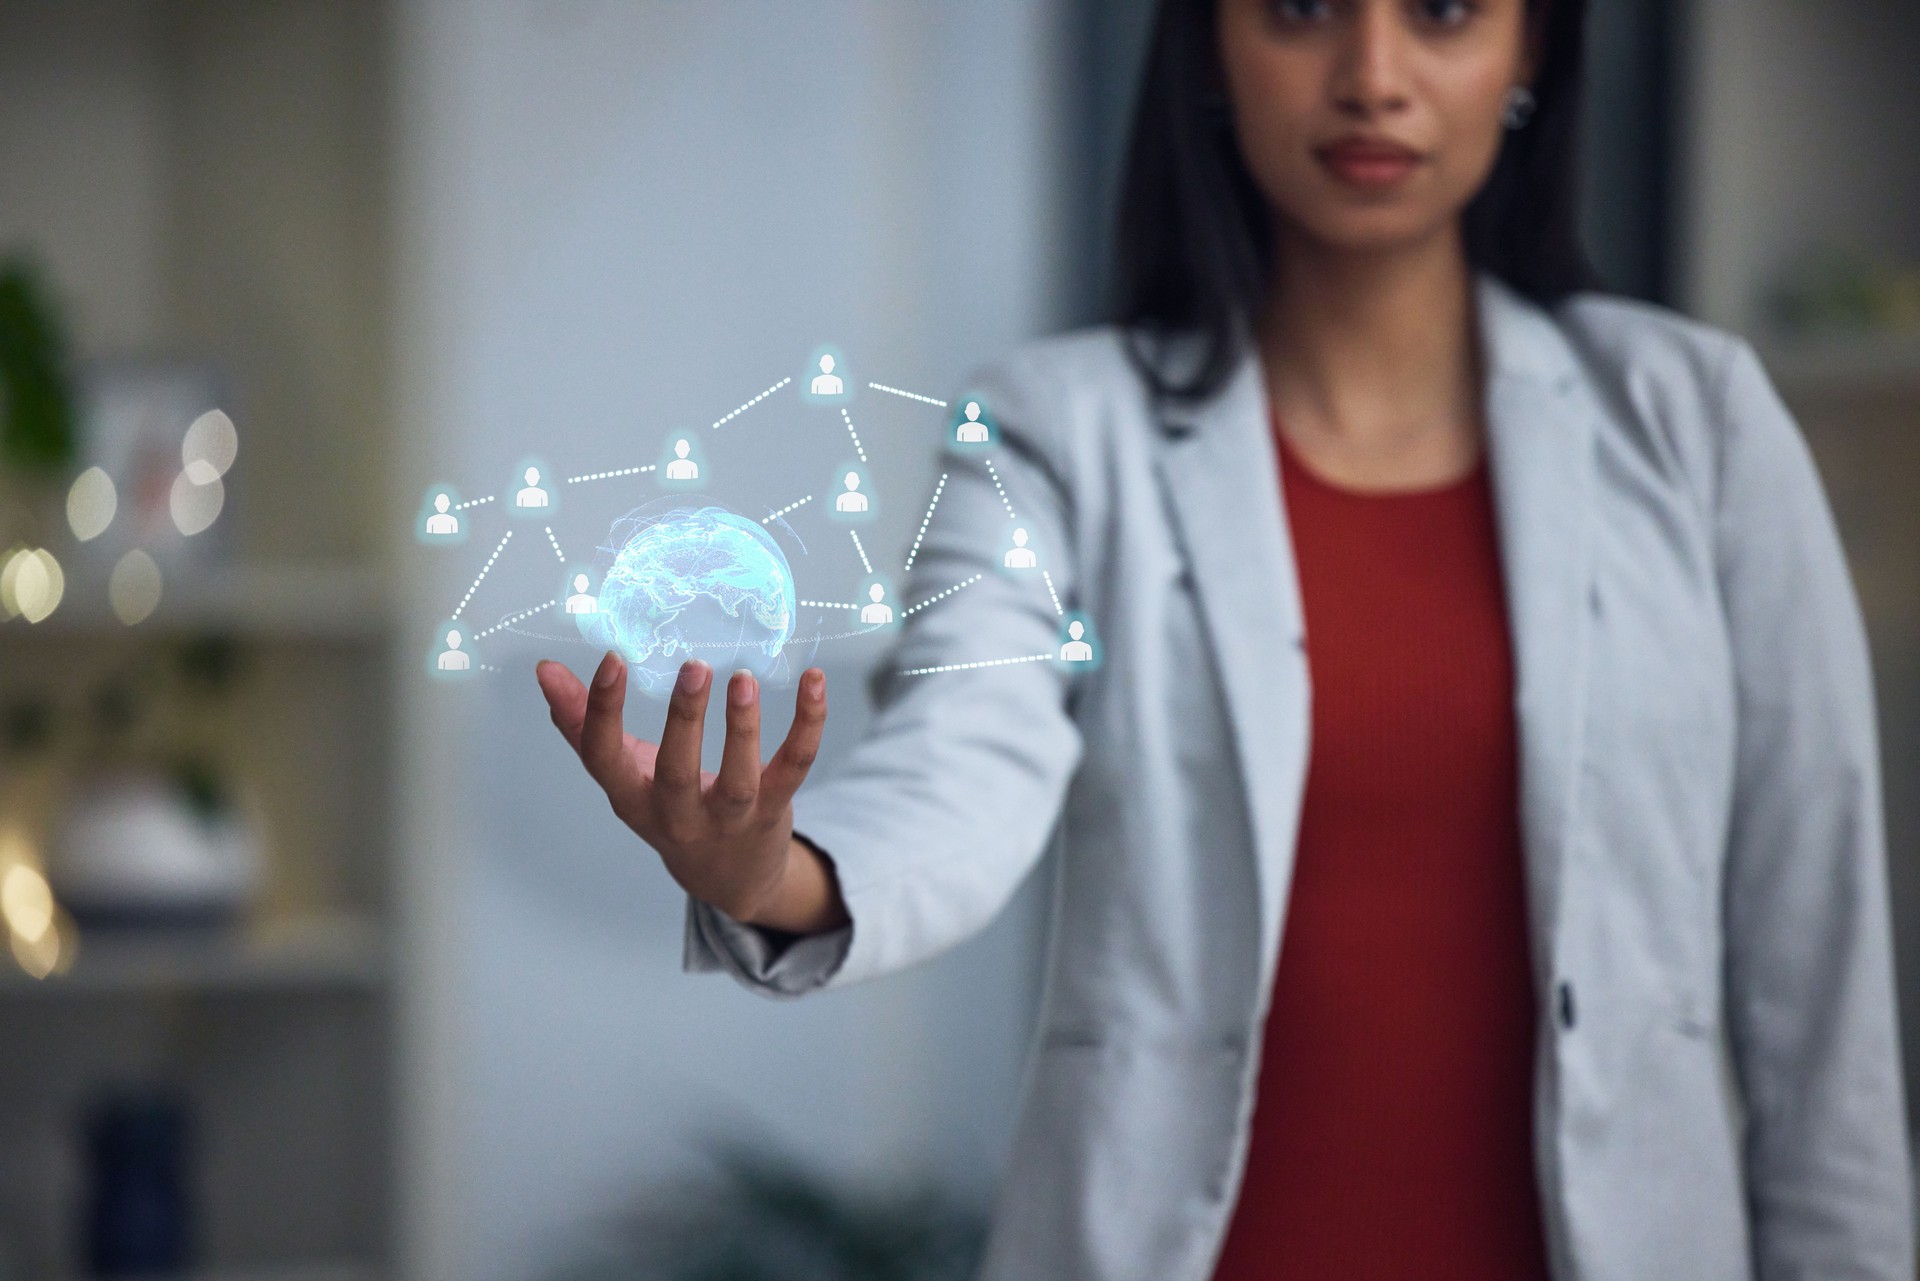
[576,507,795,697]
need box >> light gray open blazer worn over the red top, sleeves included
[685,277,1914,1281]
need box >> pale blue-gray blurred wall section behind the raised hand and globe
[392,0,1098,1281]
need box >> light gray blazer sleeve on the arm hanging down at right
[1716,342,1914,1281]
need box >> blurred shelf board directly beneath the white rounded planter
[0,914,386,1001]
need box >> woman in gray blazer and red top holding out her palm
[540,0,1912,1281]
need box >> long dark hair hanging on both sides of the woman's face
[1114,0,1599,399]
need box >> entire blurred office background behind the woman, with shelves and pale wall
[0,0,1920,1281]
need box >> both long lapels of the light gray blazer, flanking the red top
[1160,273,1599,991]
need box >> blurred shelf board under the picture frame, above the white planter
[0,564,394,643]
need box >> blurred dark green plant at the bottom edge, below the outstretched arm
[553,1143,985,1281]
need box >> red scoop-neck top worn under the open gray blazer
[1213,432,1548,1281]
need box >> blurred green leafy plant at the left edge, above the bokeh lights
[0,259,75,476]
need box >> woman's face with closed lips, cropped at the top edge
[1219,0,1530,250]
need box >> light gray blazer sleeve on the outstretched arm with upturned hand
[684,355,1081,997]
